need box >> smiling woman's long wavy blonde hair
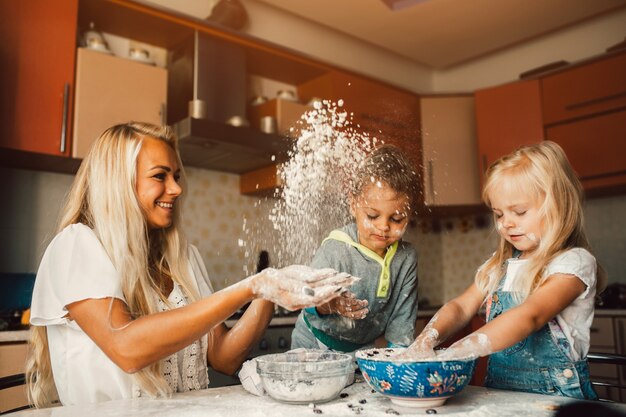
[26,122,199,407]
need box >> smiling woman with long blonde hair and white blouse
[27,123,353,407]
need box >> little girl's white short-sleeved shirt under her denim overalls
[502,248,597,361]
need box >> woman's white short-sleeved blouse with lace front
[30,223,213,405]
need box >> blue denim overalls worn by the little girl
[485,258,598,400]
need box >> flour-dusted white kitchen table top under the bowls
[11,378,626,417]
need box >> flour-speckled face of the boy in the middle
[350,182,409,257]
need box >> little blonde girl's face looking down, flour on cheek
[489,184,543,258]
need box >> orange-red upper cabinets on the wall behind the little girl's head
[475,51,626,195]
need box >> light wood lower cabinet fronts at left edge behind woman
[0,342,28,413]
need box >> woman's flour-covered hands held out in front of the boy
[242,265,360,310]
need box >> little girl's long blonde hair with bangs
[475,141,607,302]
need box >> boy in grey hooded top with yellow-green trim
[291,146,418,352]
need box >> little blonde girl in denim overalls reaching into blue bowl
[405,141,606,399]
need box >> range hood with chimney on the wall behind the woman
[167,31,291,174]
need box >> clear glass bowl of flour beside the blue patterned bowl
[256,350,354,404]
